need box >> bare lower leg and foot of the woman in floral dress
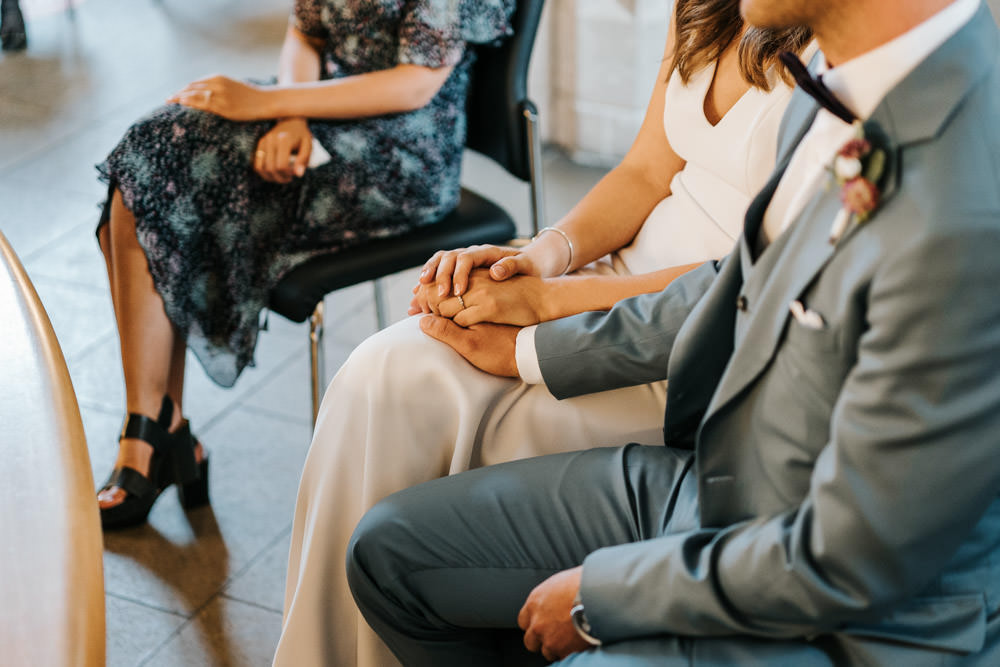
[98,191,196,507]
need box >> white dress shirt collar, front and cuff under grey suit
[515,0,981,384]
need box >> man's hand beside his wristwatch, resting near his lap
[517,565,590,662]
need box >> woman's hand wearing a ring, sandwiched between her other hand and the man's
[435,269,548,327]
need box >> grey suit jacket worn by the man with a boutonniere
[536,6,1000,665]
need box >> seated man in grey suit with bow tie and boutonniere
[348,0,1000,667]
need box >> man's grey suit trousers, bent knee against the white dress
[347,445,697,667]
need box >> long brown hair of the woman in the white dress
[673,0,812,90]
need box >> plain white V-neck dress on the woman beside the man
[275,61,791,667]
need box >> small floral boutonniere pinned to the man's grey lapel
[828,121,885,245]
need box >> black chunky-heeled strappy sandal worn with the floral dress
[98,397,208,530]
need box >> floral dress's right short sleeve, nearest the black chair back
[399,0,514,67]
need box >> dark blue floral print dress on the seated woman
[98,0,514,387]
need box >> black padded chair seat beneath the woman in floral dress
[270,188,516,322]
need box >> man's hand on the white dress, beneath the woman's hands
[420,315,520,377]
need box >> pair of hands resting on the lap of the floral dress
[167,74,312,184]
